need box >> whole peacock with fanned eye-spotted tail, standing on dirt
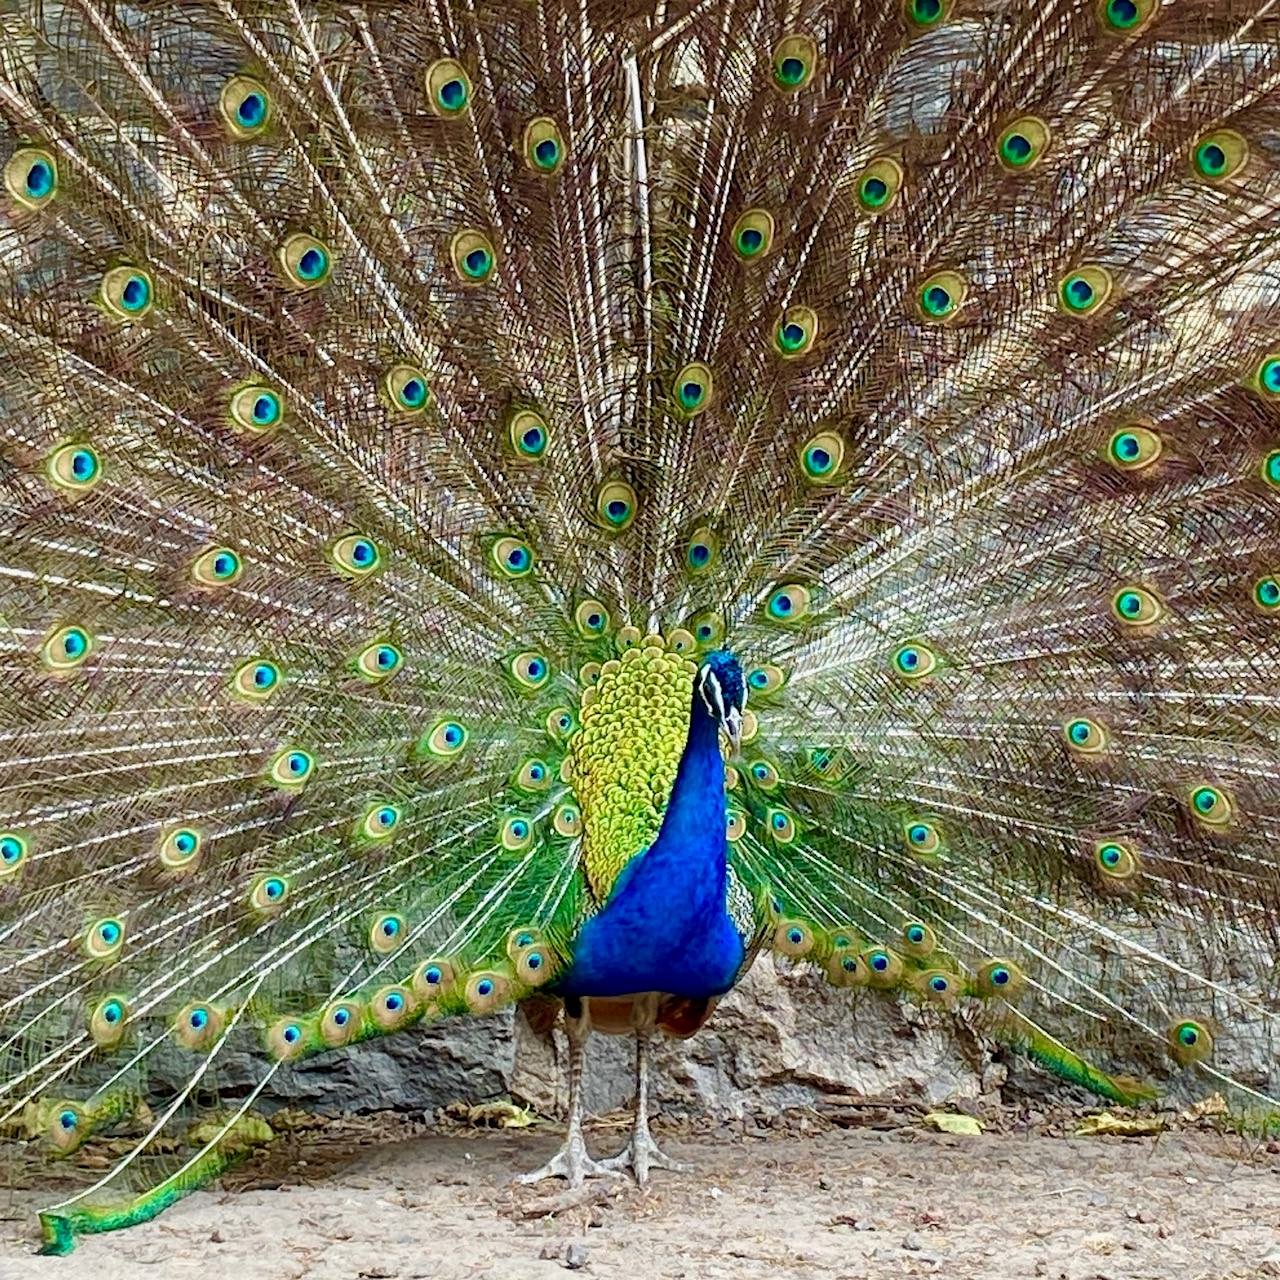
[0,0,1280,1252]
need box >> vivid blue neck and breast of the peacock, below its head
[557,694,745,998]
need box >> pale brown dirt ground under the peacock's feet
[0,1111,1280,1280]
